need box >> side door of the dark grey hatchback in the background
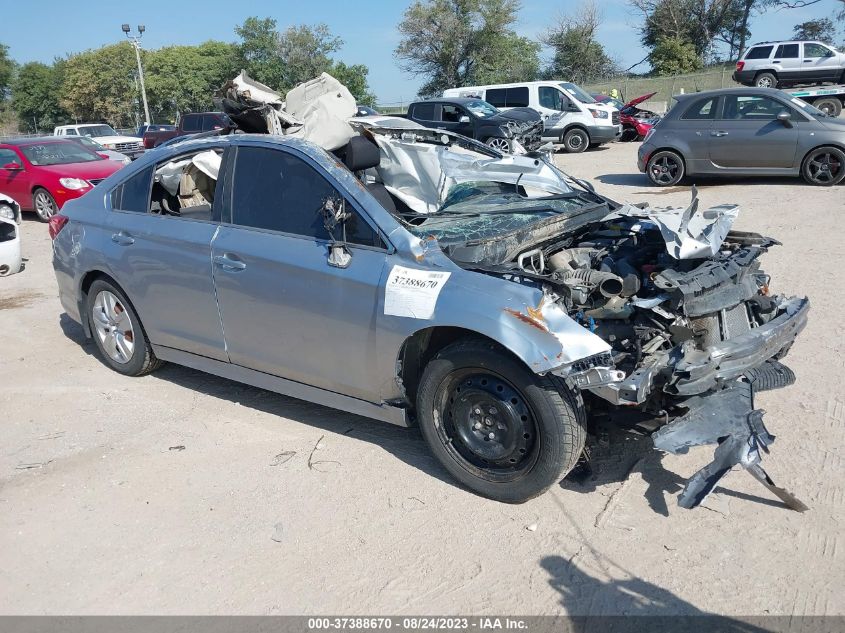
[710,91,801,170]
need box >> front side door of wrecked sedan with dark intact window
[212,144,387,401]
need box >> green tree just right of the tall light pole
[144,41,240,121]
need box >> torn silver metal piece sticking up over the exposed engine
[608,187,739,259]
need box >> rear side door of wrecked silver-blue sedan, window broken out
[102,148,228,361]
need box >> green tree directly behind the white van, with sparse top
[543,0,617,83]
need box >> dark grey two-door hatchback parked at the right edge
[637,88,845,187]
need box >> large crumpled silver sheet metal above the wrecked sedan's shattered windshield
[369,129,572,214]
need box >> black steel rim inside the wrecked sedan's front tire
[437,369,539,481]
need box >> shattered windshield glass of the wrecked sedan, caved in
[408,182,605,246]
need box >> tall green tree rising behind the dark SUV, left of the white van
[396,0,539,96]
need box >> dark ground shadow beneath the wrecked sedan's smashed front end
[560,417,789,517]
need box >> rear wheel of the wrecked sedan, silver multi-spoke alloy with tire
[86,279,162,376]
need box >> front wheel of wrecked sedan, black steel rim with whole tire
[417,339,586,503]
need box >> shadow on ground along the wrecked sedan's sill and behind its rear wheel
[59,313,460,488]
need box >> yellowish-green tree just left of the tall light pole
[60,42,140,127]
